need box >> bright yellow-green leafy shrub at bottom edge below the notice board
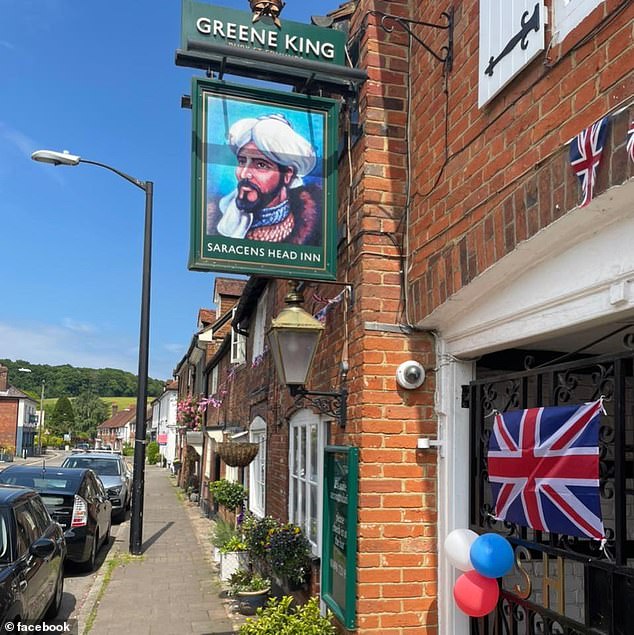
[240,595,337,635]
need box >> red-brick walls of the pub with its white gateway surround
[177,0,634,635]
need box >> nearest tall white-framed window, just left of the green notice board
[288,410,326,556]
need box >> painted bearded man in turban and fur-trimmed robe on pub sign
[207,113,322,245]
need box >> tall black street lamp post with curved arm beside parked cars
[31,150,154,555]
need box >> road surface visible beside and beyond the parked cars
[0,451,130,620]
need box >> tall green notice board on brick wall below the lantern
[321,445,359,628]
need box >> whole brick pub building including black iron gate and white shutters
[177,0,634,635]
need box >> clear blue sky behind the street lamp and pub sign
[0,0,342,379]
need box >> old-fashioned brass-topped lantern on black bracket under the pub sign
[267,282,348,428]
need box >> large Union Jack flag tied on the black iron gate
[488,400,605,540]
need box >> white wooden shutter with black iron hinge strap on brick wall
[478,0,546,108]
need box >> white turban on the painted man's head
[229,114,317,187]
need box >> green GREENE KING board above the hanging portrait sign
[181,0,345,65]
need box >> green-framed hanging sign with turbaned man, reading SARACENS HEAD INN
[189,78,338,280]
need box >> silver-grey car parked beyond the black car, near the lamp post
[62,452,132,520]
